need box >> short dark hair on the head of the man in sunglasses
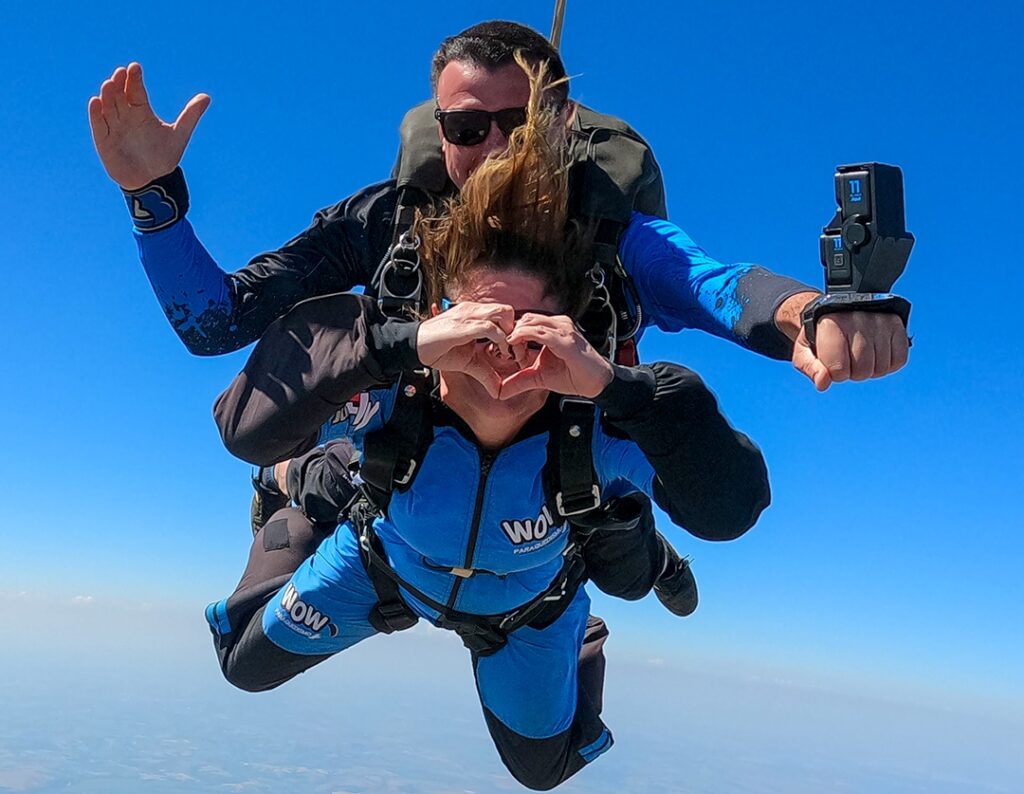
[430,19,569,103]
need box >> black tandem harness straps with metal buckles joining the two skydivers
[349,100,667,656]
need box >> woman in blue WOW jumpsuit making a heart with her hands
[207,60,769,790]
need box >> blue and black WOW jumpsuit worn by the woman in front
[208,294,769,789]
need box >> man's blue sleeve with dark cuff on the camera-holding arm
[618,212,814,359]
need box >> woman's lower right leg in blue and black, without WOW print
[473,588,612,791]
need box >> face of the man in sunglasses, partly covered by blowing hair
[437,60,529,190]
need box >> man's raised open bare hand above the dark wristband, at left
[89,64,210,191]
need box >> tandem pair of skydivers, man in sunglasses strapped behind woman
[90,17,906,789]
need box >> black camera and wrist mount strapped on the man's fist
[801,163,914,349]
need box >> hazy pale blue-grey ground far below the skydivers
[0,594,1024,794]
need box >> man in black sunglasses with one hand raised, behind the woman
[89,22,908,615]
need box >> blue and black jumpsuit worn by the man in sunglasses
[132,170,811,599]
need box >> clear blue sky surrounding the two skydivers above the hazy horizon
[0,0,1024,786]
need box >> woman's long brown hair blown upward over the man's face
[416,55,592,318]
